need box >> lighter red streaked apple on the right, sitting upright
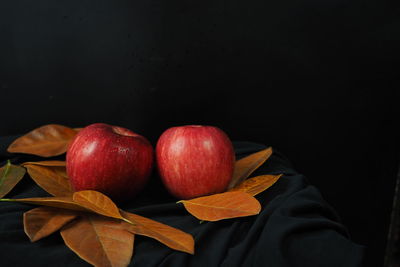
[156,125,235,199]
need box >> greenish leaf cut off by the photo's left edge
[0,161,26,198]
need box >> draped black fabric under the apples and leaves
[0,137,364,267]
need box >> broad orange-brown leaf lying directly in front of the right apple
[178,191,261,221]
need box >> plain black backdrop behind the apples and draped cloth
[0,0,400,266]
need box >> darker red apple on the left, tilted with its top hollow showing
[66,123,154,201]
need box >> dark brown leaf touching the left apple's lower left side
[23,163,73,197]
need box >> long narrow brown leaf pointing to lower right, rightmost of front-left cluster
[121,211,194,254]
